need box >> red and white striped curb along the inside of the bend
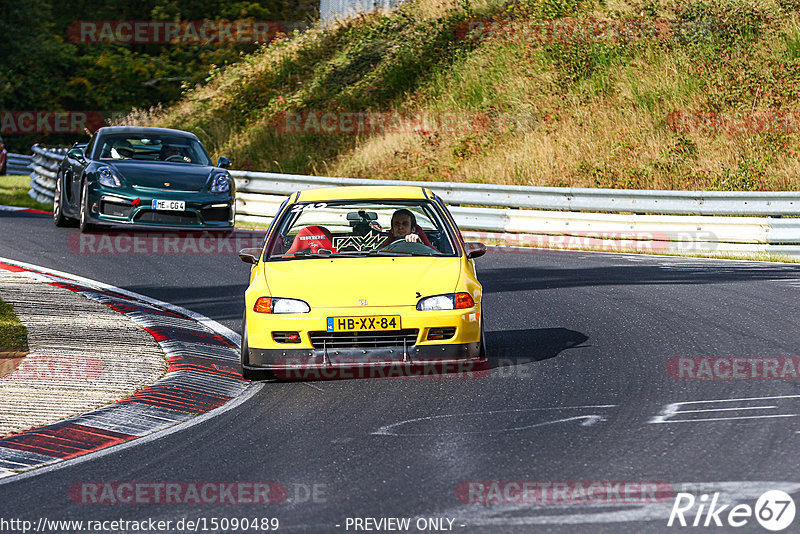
[0,258,253,482]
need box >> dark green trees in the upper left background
[0,0,319,153]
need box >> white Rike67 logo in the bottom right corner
[667,490,795,532]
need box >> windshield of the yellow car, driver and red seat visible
[266,200,456,260]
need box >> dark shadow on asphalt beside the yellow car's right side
[486,328,589,369]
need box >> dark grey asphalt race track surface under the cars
[0,208,800,534]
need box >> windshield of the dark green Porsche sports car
[97,134,211,166]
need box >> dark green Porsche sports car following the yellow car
[53,126,235,232]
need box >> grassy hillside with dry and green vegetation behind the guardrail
[134,0,800,190]
